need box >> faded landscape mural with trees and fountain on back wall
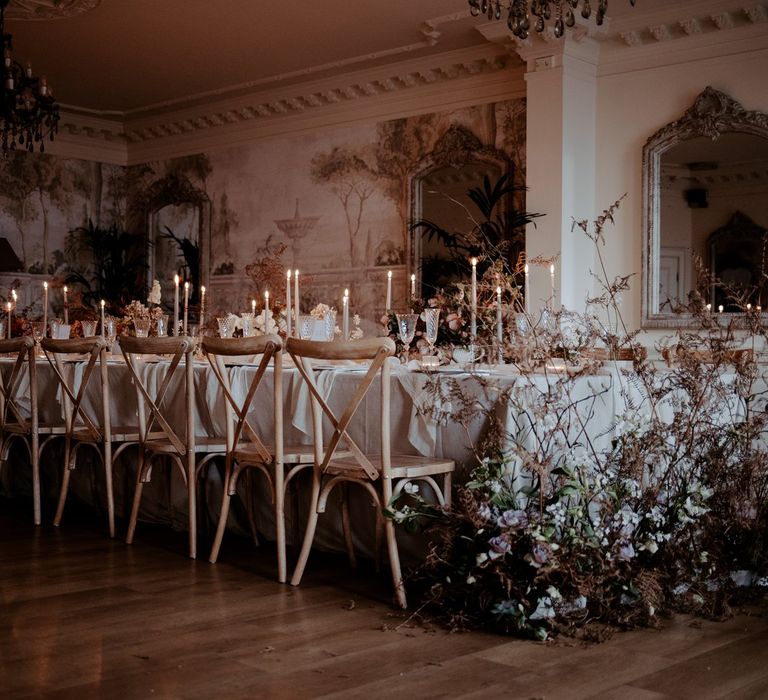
[0,100,525,322]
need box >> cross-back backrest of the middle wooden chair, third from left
[119,336,195,455]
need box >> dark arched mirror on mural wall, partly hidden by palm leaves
[406,125,512,298]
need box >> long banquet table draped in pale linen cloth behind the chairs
[3,356,656,559]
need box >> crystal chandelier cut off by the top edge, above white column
[469,0,635,39]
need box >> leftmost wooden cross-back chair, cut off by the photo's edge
[0,336,55,525]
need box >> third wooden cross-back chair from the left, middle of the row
[119,336,226,559]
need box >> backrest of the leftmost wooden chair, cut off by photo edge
[0,336,38,433]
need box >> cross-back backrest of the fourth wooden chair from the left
[202,335,283,462]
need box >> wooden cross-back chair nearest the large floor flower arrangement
[286,338,454,608]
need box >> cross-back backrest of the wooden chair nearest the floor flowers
[286,338,395,479]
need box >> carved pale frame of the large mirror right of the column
[641,86,768,328]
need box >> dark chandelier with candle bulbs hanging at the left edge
[0,0,60,154]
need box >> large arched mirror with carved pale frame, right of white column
[643,87,768,328]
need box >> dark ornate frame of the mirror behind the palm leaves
[405,124,514,290]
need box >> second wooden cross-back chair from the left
[40,336,115,537]
